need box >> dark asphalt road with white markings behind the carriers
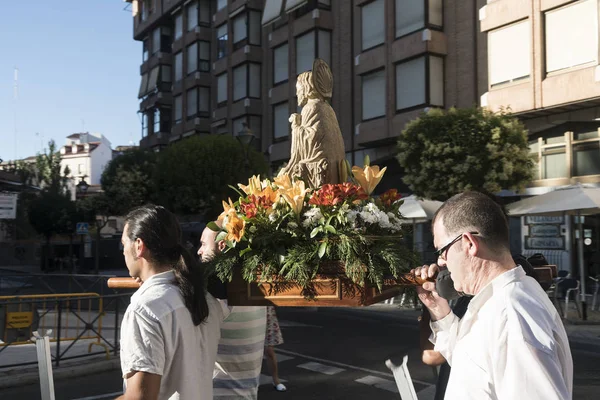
[0,307,600,400]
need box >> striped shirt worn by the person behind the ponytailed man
[213,306,267,400]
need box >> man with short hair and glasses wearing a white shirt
[415,192,573,400]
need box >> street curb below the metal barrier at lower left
[0,357,121,389]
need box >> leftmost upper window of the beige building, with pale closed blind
[488,20,531,86]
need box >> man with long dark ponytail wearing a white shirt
[119,205,227,400]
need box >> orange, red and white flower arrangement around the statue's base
[208,159,415,296]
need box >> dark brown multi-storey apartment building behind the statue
[132,0,487,181]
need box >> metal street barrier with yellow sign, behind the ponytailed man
[0,293,131,368]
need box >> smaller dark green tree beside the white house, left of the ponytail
[101,149,156,215]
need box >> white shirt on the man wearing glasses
[430,266,573,400]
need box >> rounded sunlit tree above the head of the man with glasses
[397,108,534,201]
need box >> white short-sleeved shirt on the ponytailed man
[121,271,228,400]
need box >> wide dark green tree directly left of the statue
[157,135,268,218]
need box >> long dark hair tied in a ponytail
[125,204,208,325]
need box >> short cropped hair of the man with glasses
[432,191,510,250]
